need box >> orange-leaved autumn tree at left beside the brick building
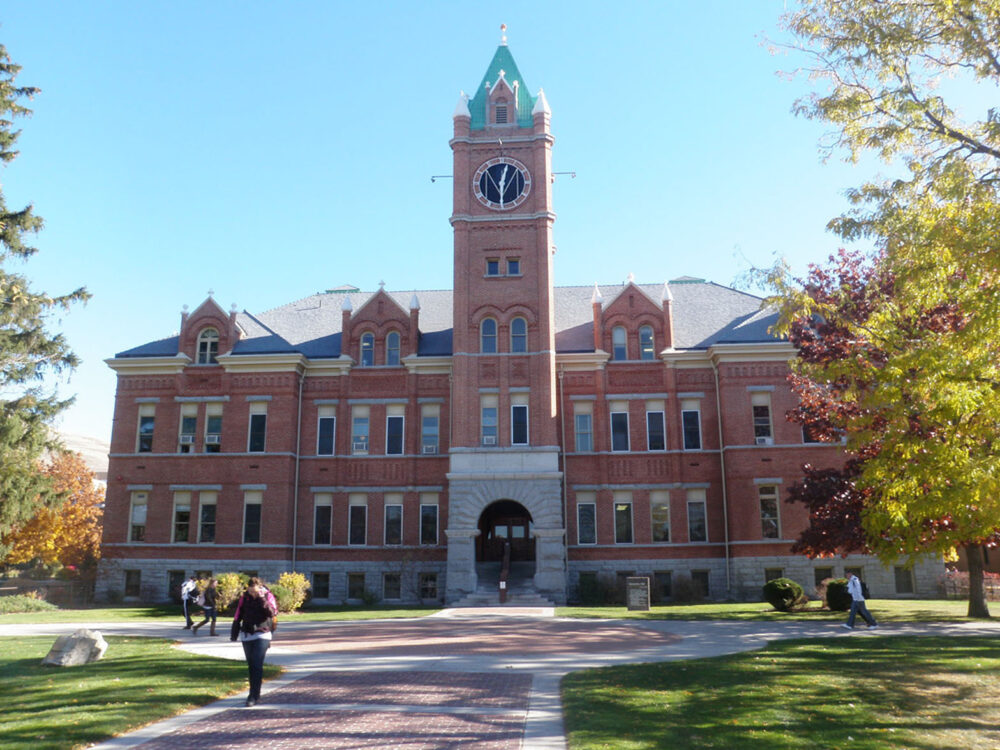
[3,453,104,571]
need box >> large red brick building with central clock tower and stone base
[99,39,941,603]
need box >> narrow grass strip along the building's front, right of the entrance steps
[560,599,980,622]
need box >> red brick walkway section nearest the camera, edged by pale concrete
[139,671,532,750]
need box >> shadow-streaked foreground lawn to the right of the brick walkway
[562,636,1000,750]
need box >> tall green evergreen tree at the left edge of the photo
[0,45,89,552]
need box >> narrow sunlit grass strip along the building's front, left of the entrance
[0,604,441,632]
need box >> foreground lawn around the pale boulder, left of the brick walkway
[0,636,281,750]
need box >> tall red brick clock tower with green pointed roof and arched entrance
[446,30,566,601]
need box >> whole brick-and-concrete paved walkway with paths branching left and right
[7,609,1000,750]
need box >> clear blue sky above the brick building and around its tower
[0,0,872,439]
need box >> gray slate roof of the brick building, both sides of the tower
[116,278,776,359]
